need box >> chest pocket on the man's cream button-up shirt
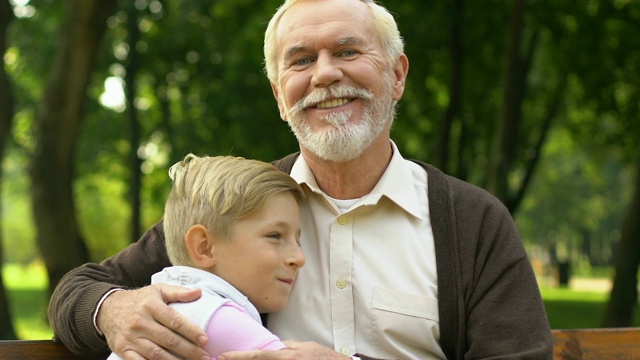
[371,288,440,354]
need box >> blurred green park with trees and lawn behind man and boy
[0,0,640,338]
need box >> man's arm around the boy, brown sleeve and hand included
[49,223,204,357]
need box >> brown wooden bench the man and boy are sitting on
[0,328,640,360]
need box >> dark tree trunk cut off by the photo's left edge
[0,0,16,339]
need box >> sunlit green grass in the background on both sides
[2,263,640,340]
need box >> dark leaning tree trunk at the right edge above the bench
[604,156,640,327]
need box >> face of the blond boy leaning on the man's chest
[213,192,305,312]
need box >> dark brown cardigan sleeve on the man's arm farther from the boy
[436,167,553,359]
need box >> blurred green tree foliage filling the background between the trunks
[1,0,640,290]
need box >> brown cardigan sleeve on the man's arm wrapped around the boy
[48,222,170,355]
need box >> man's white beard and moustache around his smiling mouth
[288,82,395,162]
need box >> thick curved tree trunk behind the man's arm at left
[30,0,116,296]
